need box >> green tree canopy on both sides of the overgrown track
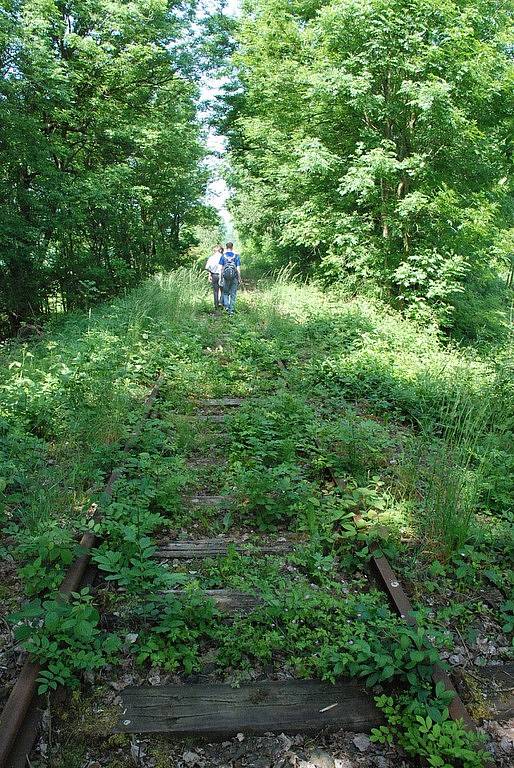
[0,0,508,336]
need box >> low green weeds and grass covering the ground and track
[0,272,513,768]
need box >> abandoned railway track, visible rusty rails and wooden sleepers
[0,350,482,768]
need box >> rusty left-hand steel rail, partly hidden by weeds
[0,376,163,768]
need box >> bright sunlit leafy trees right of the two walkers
[221,0,514,334]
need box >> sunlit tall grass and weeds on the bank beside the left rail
[0,269,205,530]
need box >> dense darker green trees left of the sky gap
[0,0,212,332]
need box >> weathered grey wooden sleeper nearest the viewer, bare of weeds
[115,680,384,735]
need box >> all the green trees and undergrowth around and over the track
[0,0,514,768]
